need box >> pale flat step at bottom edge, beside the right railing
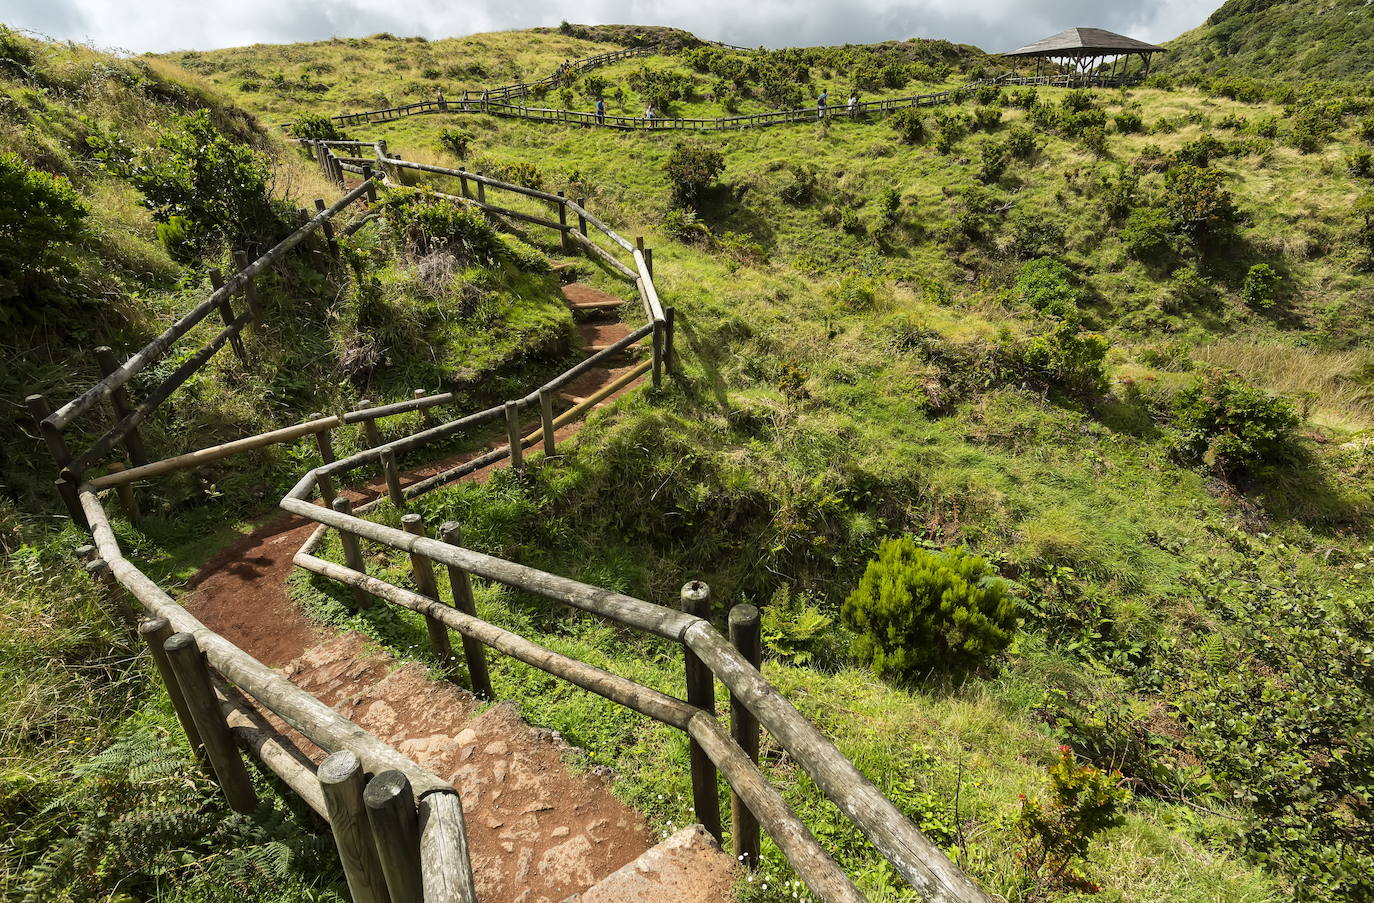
[563,825,738,903]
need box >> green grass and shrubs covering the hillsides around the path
[0,12,1374,903]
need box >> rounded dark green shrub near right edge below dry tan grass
[1169,370,1298,478]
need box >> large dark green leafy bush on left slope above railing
[126,110,279,254]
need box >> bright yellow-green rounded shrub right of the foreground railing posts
[841,536,1017,680]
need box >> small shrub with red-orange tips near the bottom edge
[1014,746,1131,893]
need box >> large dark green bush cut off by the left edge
[0,154,87,307]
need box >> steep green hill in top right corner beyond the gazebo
[1161,0,1374,82]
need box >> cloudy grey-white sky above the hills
[0,0,1220,52]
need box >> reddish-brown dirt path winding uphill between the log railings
[185,277,654,903]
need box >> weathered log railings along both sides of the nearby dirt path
[36,135,991,903]
